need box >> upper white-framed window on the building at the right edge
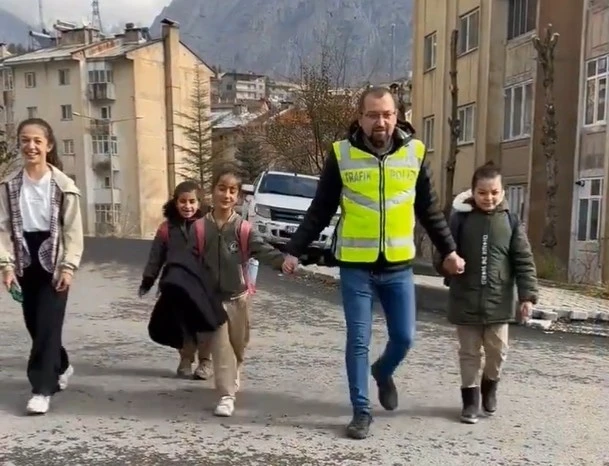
[584,55,609,125]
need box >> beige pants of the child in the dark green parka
[457,324,509,388]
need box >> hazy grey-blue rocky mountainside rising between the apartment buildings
[151,0,414,82]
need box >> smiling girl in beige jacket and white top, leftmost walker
[0,118,83,414]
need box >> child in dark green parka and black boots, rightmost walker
[447,163,538,424]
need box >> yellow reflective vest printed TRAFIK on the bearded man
[334,139,425,263]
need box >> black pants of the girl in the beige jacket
[19,232,70,396]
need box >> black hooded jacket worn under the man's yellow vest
[286,122,456,271]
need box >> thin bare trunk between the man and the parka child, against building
[444,29,461,218]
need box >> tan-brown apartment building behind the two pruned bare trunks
[412,0,580,276]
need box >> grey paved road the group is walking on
[0,240,609,466]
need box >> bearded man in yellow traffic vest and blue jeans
[283,87,465,439]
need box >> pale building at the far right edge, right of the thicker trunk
[564,0,609,283]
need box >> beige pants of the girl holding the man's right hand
[211,296,250,397]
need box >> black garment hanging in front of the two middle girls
[148,250,228,349]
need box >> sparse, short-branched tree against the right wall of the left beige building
[176,67,219,195]
